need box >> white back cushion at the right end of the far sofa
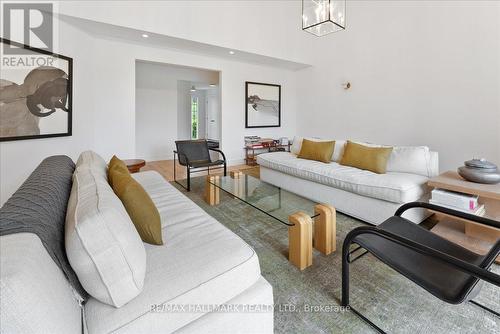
[387,146,432,177]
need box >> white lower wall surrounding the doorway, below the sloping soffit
[0,13,296,204]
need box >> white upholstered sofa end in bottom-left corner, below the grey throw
[0,233,82,334]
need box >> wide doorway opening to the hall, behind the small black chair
[135,60,221,161]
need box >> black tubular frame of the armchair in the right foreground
[342,202,500,333]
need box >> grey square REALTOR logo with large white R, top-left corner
[2,3,54,55]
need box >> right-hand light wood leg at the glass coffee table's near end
[314,204,337,255]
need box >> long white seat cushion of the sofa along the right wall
[257,152,428,203]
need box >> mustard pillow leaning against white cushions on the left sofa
[108,157,163,245]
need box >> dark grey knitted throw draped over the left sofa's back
[0,155,87,299]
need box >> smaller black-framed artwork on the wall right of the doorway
[245,81,281,128]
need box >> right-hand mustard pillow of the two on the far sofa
[340,140,392,174]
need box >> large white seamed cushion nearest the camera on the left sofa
[65,168,146,307]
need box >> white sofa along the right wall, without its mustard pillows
[257,138,439,225]
